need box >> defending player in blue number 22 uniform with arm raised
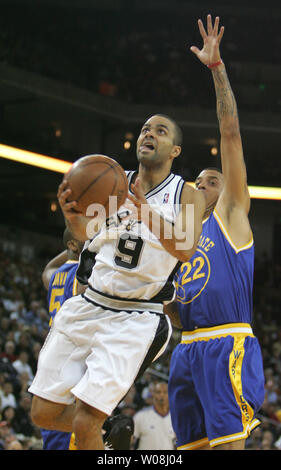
[164,15,264,450]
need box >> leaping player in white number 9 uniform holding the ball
[29,115,206,450]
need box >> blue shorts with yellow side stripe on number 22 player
[169,323,264,450]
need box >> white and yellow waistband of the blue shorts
[181,323,255,344]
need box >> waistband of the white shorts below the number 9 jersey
[83,288,163,313]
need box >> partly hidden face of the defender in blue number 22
[195,170,223,205]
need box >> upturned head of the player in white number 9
[137,115,180,166]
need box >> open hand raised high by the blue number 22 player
[190,15,224,65]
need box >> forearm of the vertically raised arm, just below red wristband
[212,64,239,134]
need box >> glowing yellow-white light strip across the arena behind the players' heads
[0,144,281,201]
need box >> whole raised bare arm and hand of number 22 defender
[191,15,250,214]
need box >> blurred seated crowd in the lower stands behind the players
[0,232,281,450]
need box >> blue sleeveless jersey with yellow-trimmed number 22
[175,210,254,331]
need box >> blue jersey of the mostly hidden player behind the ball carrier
[48,260,78,323]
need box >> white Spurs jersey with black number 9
[77,171,184,309]
